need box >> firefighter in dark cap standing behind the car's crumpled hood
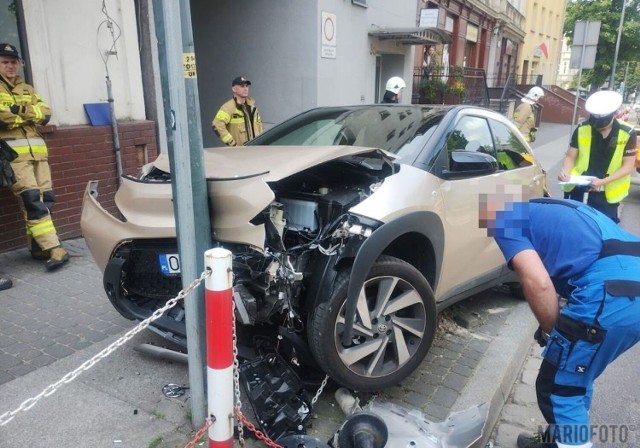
[212,76,263,146]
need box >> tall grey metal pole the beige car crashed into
[162,0,211,428]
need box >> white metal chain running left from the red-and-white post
[0,269,211,426]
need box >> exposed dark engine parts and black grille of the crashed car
[105,152,395,348]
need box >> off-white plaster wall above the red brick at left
[22,0,145,126]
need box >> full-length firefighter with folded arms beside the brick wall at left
[0,43,69,270]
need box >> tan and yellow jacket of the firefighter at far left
[0,75,51,162]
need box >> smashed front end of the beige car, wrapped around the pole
[81,147,397,345]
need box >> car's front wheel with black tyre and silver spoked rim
[308,256,437,391]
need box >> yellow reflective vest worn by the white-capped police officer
[562,125,631,204]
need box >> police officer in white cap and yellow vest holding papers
[558,90,636,223]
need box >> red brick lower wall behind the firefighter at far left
[0,121,158,252]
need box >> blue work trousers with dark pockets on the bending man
[536,257,640,446]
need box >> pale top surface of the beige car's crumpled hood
[152,146,393,182]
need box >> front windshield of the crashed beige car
[248,105,446,158]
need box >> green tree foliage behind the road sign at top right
[564,0,640,90]
